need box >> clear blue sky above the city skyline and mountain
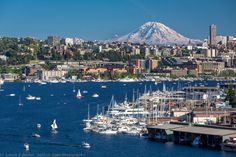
[0,0,236,40]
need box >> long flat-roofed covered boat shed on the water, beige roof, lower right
[147,123,236,148]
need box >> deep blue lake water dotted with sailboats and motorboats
[0,81,236,157]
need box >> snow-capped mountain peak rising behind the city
[113,22,201,45]
